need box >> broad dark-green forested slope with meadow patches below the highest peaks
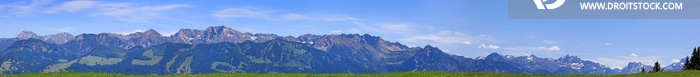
[45,40,386,74]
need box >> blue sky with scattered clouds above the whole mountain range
[0,0,700,67]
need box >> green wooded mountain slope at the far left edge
[0,38,77,74]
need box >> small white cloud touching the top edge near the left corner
[45,1,97,13]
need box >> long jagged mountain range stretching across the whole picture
[0,26,684,74]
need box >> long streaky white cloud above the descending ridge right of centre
[348,21,501,49]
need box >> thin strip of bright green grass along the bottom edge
[0,71,700,77]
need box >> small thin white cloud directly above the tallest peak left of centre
[211,7,271,18]
